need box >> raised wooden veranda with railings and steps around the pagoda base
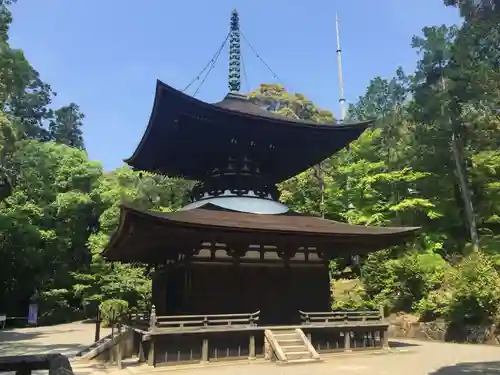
[103,309,388,366]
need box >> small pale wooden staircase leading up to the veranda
[265,329,321,364]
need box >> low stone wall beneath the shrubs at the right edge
[387,314,500,345]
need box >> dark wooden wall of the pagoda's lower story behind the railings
[153,263,330,325]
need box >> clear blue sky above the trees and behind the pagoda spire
[11,0,459,170]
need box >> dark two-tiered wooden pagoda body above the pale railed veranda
[104,9,416,368]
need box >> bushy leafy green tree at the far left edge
[0,141,102,320]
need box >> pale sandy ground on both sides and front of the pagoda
[0,323,500,375]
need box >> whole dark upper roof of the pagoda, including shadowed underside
[125,81,373,183]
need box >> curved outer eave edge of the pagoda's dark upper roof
[124,80,375,166]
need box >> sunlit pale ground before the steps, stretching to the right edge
[129,341,500,375]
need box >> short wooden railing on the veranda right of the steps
[299,310,383,325]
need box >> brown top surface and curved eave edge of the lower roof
[103,205,420,261]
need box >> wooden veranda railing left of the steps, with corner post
[145,307,260,331]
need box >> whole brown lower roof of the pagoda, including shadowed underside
[103,204,418,263]
